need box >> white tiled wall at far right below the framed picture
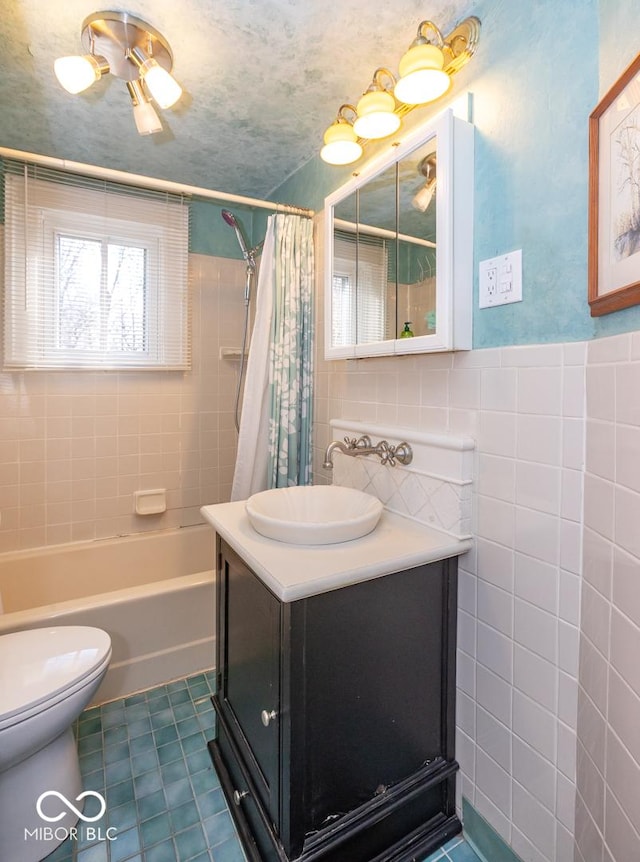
[576,333,640,862]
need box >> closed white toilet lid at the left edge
[0,626,111,719]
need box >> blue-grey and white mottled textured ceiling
[0,0,473,198]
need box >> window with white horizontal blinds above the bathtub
[4,162,190,369]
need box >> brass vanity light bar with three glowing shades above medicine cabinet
[320,15,480,165]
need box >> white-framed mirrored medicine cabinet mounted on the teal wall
[325,110,473,359]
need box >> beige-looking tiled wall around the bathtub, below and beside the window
[0,255,244,552]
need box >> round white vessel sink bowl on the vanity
[246,485,383,545]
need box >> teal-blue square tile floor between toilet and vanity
[41,673,479,862]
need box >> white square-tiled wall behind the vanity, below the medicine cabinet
[316,322,584,862]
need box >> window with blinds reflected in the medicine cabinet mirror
[331,231,388,347]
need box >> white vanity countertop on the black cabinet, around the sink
[200,500,471,602]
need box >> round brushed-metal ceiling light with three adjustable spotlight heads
[54,12,182,135]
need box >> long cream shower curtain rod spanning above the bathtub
[0,147,314,218]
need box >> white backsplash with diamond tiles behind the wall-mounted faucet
[331,420,475,538]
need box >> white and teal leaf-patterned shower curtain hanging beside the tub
[231,214,313,500]
